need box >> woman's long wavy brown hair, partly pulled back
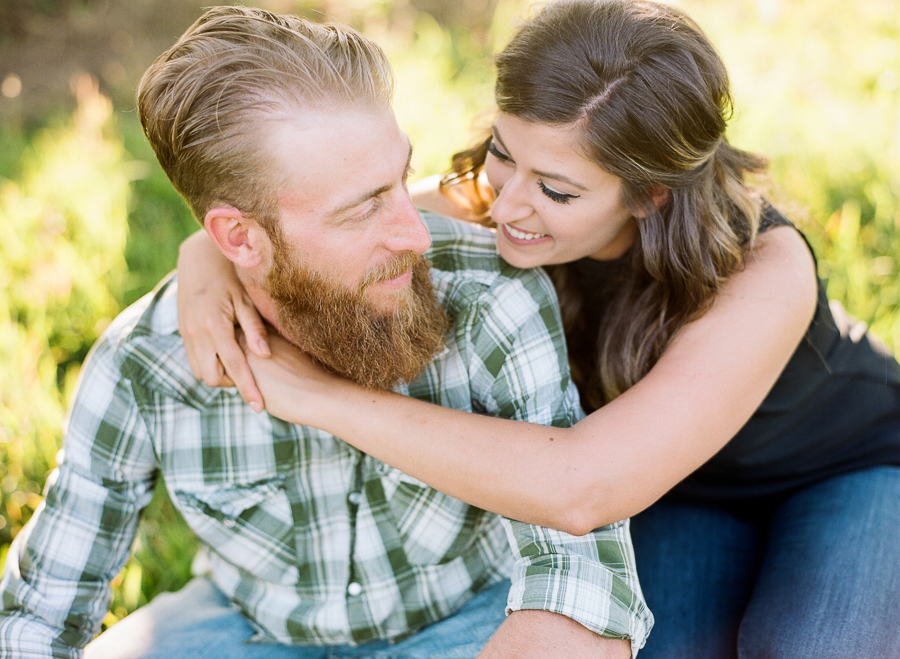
[442,0,767,411]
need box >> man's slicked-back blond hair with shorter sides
[137,7,393,231]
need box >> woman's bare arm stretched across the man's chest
[250,228,816,534]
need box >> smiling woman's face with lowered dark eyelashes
[485,113,637,268]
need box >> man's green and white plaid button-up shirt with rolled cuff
[0,215,652,657]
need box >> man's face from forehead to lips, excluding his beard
[266,109,431,314]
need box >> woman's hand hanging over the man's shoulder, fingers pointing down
[178,231,269,412]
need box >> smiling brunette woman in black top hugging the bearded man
[179,0,900,658]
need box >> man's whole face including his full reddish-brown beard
[266,105,448,388]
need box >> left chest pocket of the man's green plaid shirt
[170,476,297,584]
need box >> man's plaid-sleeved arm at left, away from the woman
[0,332,156,659]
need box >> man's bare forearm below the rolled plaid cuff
[478,611,631,659]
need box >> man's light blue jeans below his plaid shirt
[84,577,509,659]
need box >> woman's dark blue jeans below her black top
[631,466,900,659]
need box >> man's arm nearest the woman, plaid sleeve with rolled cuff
[460,273,653,656]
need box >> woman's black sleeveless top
[573,206,900,501]
